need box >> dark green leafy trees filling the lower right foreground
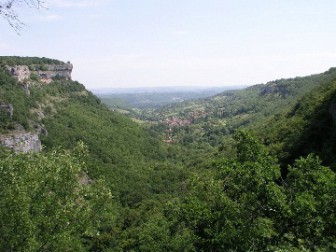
[175,132,336,251]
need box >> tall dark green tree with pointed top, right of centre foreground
[181,132,286,251]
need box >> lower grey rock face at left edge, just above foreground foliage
[0,132,42,153]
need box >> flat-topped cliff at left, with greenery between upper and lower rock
[0,56,73,152]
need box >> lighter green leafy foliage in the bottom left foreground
[0,145,111,251]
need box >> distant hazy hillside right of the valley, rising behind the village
[139,68,336,150]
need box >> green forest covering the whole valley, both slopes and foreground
[0,57,336,251]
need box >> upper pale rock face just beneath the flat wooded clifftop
[7,62,73,83]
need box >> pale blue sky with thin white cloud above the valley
[0,0,336,89]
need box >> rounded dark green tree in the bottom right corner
[282,154,336,251]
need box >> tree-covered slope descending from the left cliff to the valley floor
[0,58,185,249]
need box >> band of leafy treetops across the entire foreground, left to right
[0,132,336,251]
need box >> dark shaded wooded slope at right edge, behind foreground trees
[256,68,336,167]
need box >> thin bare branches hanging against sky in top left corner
[0,0,44,32]
